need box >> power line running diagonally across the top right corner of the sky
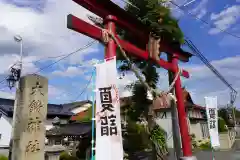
[169,0,240,39]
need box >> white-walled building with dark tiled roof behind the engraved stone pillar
[0,98,92,148]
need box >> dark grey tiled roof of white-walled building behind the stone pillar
[0,98,91,117]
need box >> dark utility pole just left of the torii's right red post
[168,55,182,160]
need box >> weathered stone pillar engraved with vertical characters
[11,75,48,160]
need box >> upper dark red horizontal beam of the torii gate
[73,0,192,62]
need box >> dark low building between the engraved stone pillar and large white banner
[46,121,92,159]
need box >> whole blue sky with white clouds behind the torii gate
[0,0,240,107]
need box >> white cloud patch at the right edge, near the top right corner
[208,5,240,35]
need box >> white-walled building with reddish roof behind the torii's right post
[120,88,209,148]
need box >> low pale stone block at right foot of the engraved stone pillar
[45,145,66,160]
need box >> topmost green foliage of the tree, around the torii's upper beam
[123,0,184,47]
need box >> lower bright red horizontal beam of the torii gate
[67,14,189,78]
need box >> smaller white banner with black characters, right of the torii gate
[205,97,220,148]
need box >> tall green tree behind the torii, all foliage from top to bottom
[117,0,184,159]
